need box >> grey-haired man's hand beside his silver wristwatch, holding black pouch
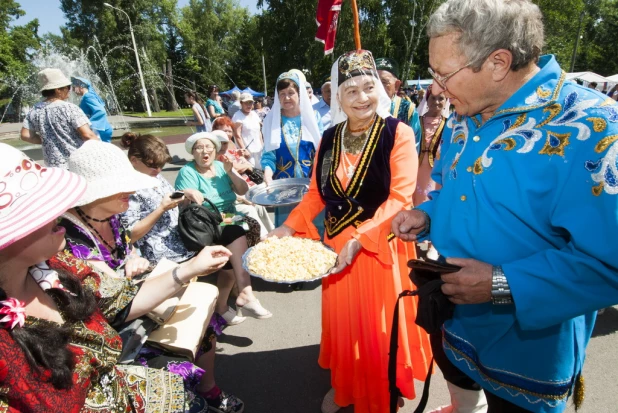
[442,258,493,304]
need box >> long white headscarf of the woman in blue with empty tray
[262,71,322,152]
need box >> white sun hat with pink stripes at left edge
[0,143,86,250]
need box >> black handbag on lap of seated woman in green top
[178,199,223,251]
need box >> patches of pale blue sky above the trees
[14,0,257,35]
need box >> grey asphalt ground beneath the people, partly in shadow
[19,135,618,413]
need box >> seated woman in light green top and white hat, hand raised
[176,132,272,319]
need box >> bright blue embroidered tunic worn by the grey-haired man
[420,56,618,412]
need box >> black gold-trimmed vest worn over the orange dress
[316,117,400,238]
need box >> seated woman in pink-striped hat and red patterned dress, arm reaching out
[0,144,243,413]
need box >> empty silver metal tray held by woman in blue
[246,178,311,207]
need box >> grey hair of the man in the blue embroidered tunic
[427,0,544,71]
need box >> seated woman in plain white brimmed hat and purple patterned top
[60,141,242,412]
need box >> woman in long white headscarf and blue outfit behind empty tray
[262,70,324,226]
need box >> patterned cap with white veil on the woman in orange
[330,50,391,127]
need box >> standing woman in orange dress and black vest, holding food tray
[271,51,431,413]
